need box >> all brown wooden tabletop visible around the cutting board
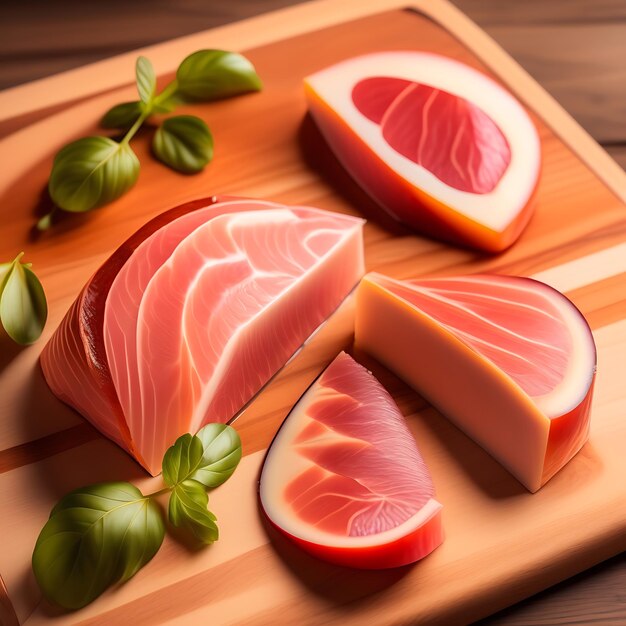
[0,0,626,626]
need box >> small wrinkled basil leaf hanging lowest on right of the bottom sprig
[168,480,219,543]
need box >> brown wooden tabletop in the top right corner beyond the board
[455,0,626,177]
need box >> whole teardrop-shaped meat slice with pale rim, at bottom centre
[259,352,443,569]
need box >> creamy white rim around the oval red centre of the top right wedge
[306,52,541,232]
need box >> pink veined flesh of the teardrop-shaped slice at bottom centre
[285,354,434,537]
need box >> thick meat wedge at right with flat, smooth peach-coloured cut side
[355,274,596,492]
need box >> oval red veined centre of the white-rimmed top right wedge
[352,77,511,194]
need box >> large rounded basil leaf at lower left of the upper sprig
[48,137,139,212]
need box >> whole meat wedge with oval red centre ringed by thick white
[305,51,541,252]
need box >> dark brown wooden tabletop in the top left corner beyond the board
[0,0,308,89]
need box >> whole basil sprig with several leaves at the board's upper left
[37,50,262,230]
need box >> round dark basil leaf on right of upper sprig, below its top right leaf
[152,115,213,174]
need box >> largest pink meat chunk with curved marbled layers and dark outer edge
[41,199,363,474]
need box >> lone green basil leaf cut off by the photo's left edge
[0,253,48,345]
